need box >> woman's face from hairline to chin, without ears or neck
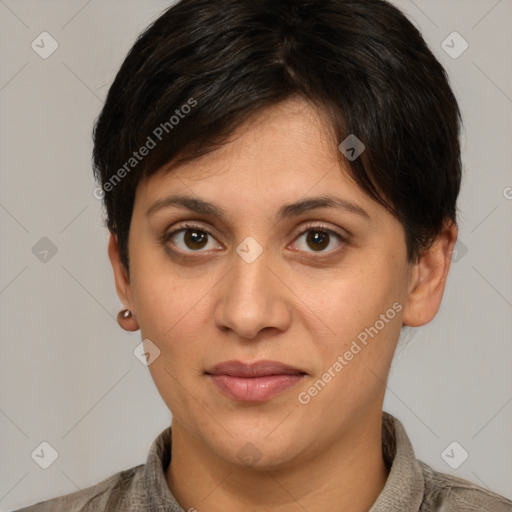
[119,100,412,467]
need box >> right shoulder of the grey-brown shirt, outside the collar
[418,461,512,512]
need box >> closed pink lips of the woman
[205,361,307,402]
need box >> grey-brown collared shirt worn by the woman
[15,411,512,512]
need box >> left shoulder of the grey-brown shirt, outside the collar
[13,464,145,512]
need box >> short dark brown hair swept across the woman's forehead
[93,0,461,270]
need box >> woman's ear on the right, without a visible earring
[403,221,458,327]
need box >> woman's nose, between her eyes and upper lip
[214,243,292,340]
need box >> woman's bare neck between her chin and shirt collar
[166,411,389,512]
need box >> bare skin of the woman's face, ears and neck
[109,99,457,512]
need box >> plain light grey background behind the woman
[0,0,512,510]
